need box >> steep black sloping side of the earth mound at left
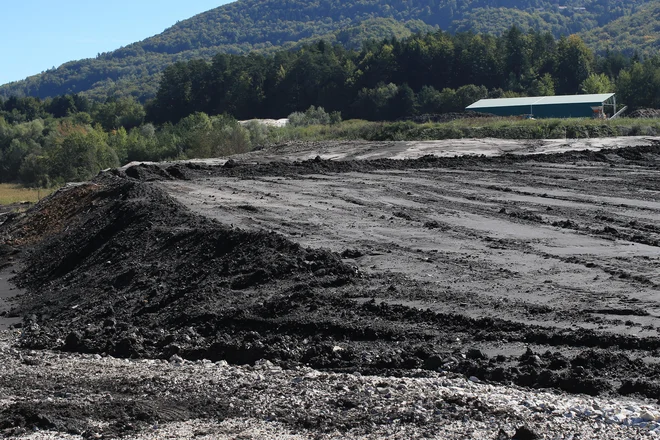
[3,175,355,357]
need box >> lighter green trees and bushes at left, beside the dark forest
[0,95,253,187]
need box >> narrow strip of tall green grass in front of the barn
[266,118,660,143]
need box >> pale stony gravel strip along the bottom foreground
[0,331,660,440]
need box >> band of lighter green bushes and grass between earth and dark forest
[0,100,660,188]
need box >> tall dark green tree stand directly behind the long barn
[146,26,660,123]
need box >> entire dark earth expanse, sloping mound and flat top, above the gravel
[0,141,660,438]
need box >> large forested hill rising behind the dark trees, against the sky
[0,0,658,100]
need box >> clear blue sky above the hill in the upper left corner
[0,0,230,84]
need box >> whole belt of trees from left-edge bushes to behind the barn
[0,27,660,186]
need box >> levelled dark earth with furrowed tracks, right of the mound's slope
[164,143,660,398]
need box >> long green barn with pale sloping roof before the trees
[465,93,616,118]
